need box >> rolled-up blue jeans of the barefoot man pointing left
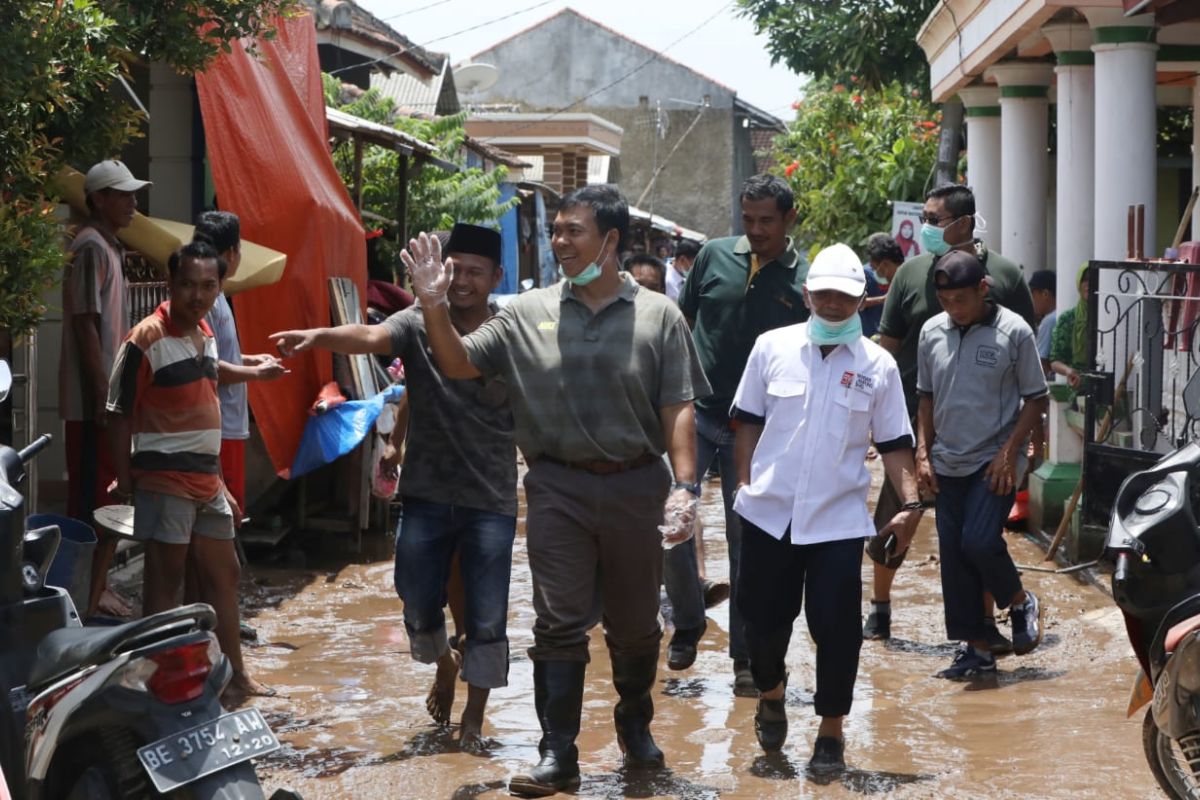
[396,498,517,688]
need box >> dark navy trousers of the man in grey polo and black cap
[936,467,1021,642]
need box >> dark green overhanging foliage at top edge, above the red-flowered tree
[738,0,938,92]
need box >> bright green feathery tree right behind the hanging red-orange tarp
[324,74,520,271]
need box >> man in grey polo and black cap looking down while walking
[917,251,1046,680]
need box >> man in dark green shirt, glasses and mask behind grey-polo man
[863,185,1036,652]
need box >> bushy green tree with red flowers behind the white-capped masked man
[775,76,941,257]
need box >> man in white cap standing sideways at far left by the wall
[59,160,150,616]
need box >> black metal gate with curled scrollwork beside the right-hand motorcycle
[1084,261,1200,525]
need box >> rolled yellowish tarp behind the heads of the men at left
[58,169,288,294]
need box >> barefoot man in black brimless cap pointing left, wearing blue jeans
[271,223,517,748]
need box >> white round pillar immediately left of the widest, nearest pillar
[1042,23,1096,311]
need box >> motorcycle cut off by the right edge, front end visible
[1105,417,1200,799]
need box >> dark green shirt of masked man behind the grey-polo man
[880,241,1037,415]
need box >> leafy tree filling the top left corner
[0,0,298,335]
